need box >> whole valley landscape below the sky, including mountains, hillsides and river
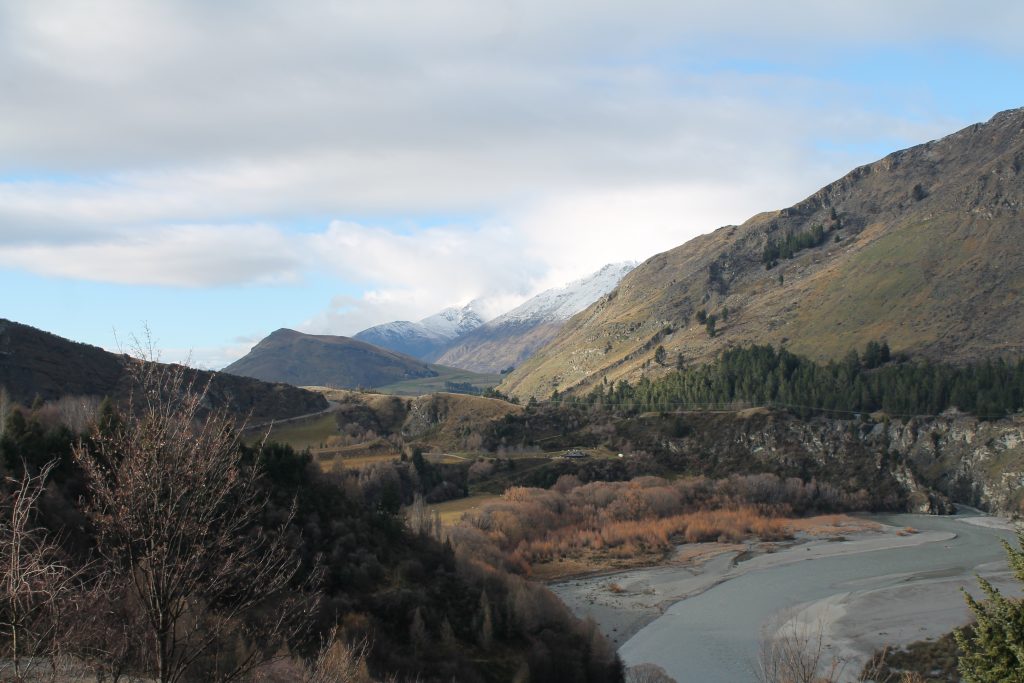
[0,110,1024,683]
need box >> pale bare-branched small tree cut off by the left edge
[0,461,78,681]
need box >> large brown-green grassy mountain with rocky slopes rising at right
[501,104,1024,397]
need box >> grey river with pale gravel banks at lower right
[553,513,1016,683]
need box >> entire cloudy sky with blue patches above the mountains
[0,0,1024,368]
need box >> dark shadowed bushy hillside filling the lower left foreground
[0,365,623,683]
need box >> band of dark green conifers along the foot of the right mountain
[580,341,1024,419]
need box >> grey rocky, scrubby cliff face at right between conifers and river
[649,413,1024,515]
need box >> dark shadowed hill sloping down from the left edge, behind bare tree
[0,318,328,420]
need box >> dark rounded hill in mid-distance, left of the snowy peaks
[224,329,437,388]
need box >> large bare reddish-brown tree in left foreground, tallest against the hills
[75,360,313,683]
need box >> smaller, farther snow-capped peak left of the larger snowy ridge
[352,302,483,361]
